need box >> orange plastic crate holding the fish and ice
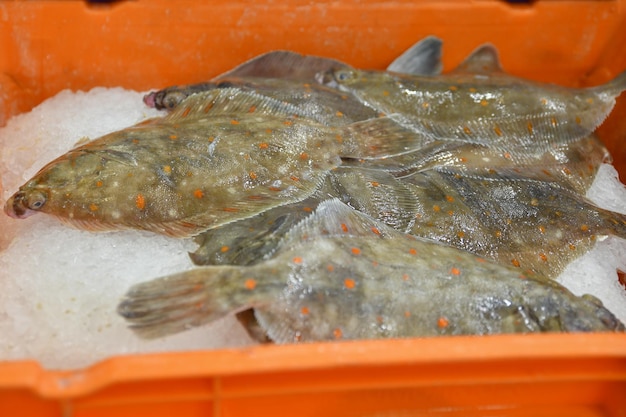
[0,0,626,417]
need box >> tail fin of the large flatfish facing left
[338,114,430,159]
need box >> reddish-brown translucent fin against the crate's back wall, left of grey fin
[215,51,348,81]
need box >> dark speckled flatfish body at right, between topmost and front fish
[403,168,626,278]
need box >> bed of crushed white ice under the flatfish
[0,88,626,369]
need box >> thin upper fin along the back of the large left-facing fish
[161,88,304,123]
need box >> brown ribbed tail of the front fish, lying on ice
[117,266,270,339]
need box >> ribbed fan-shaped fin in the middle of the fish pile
[333,168,419,232]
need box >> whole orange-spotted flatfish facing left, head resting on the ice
[5,89,420,237]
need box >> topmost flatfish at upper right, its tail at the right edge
[317,45,626,154]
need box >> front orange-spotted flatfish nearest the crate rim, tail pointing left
[118,199,624,343]
